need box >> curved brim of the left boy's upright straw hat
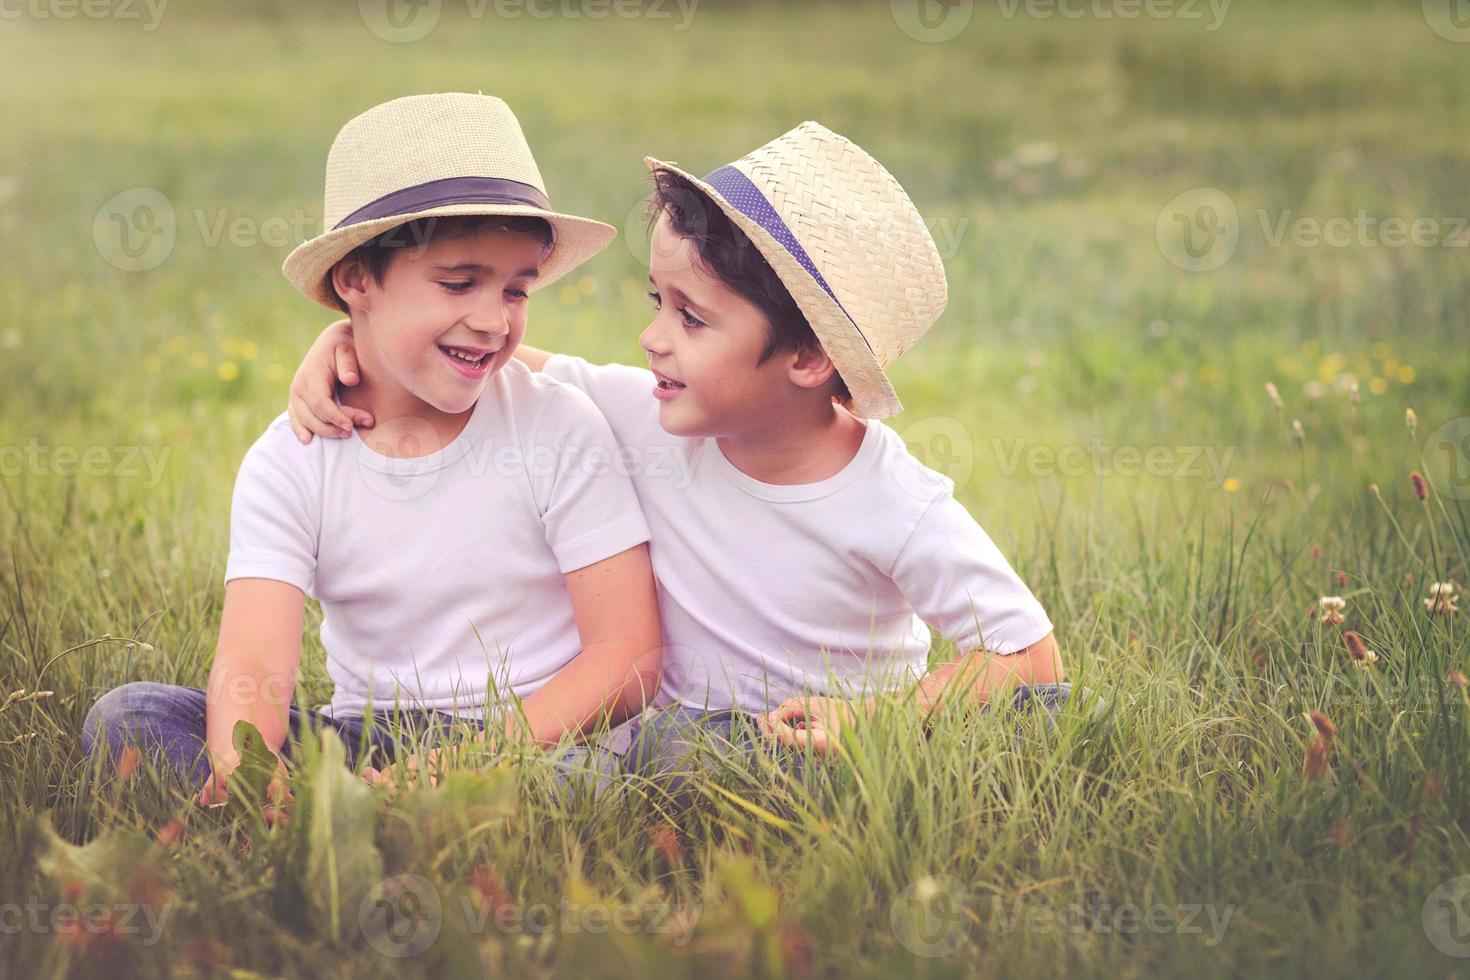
[281,204,617,311]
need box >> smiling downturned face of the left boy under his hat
[340,231,544,414]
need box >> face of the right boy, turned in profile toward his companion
[638,216,797,436]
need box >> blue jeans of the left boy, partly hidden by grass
[82,680,484,793]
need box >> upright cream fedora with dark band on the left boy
[281,93,617,310]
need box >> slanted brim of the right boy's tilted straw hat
[644,157,904,419]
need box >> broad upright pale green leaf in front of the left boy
[304,729,382,939]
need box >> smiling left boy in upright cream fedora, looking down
[84,94,662,802]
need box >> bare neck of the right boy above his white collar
[716,401,867,485]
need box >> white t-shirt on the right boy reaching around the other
[544,354,1051,710]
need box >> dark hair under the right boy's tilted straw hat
[648,166,853,408]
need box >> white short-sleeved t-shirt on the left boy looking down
[225,361,648,717]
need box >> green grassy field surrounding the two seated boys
[0,0,1470,977]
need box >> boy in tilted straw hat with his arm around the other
[291,122,1070,767]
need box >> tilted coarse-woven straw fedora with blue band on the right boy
[644,122,948,419]
